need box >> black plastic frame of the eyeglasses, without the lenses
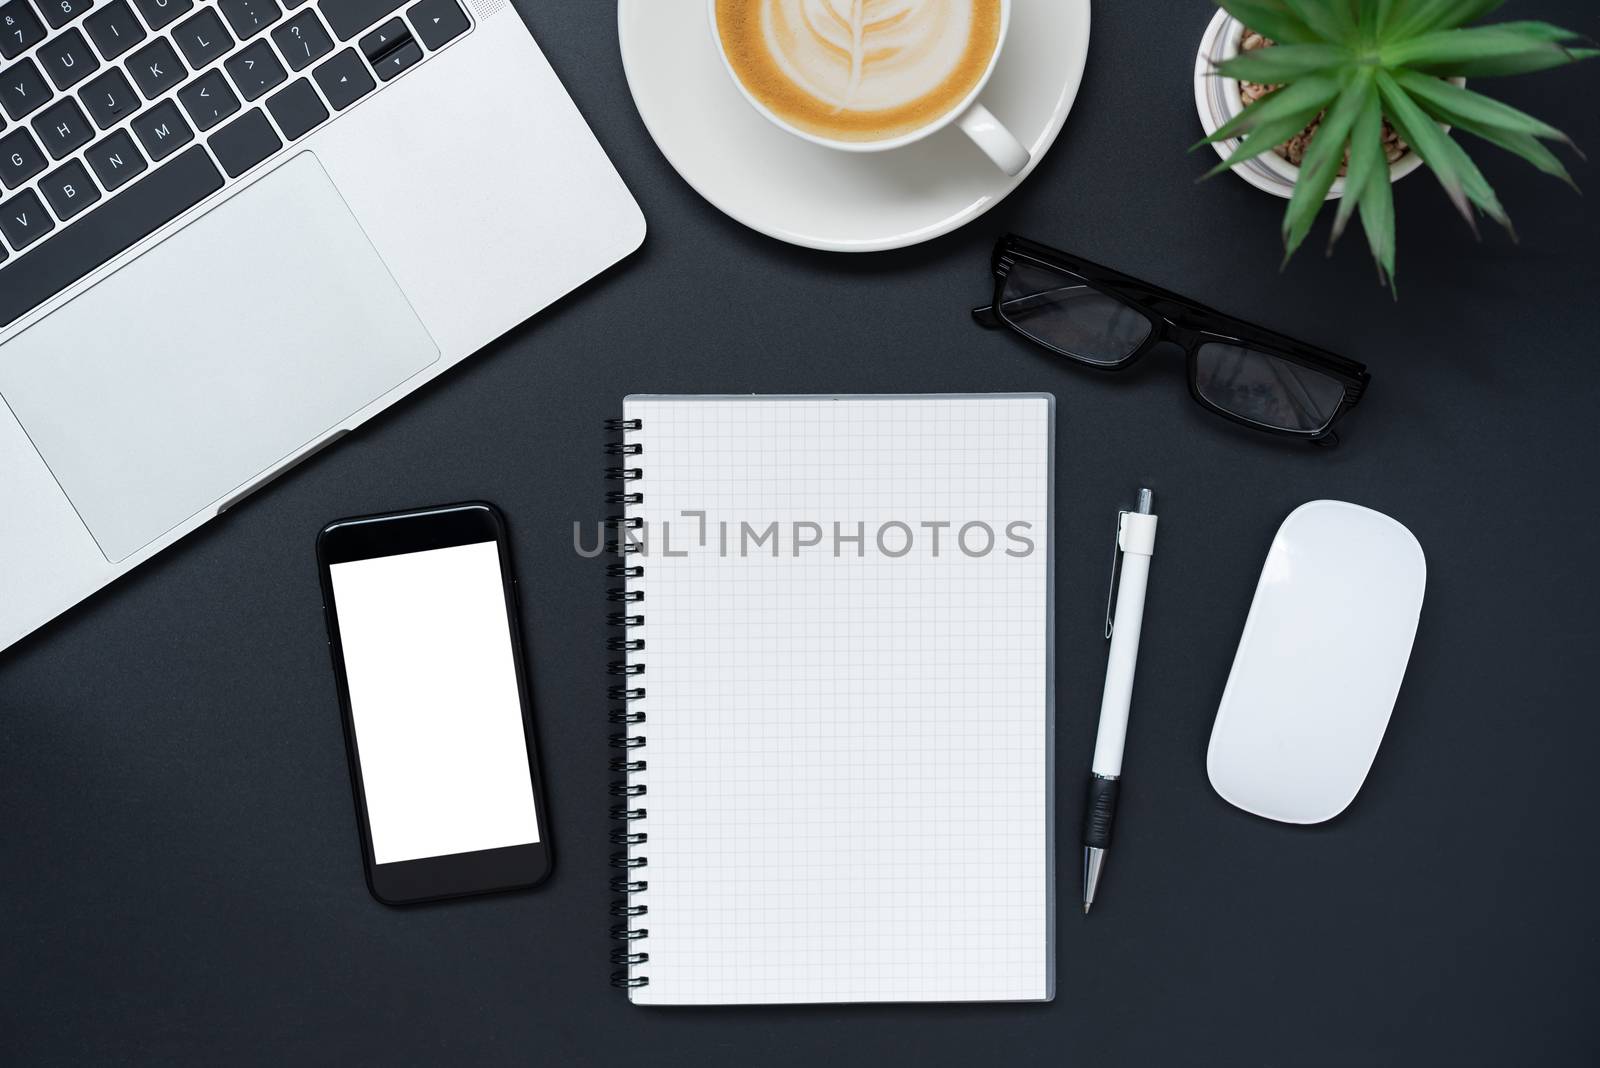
[973,233,1373,446]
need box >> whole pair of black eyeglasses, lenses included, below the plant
[973,233,1371,444]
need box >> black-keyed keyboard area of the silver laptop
[0,0,470,326]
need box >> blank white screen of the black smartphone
[330,542,539,863]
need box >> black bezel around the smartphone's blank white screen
[317,500,552,905]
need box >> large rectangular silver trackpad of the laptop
[0,153,438,563]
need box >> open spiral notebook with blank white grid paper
[606,395,1054,1006]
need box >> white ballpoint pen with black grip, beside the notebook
[1083,488,1155,915]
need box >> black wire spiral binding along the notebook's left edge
[605,419,650,990]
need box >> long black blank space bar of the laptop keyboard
[0,145,222,326]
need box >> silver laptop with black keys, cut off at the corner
[0,0,645,649]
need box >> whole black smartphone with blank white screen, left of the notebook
[317,500,550,905]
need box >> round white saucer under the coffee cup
[618,0,1090,253]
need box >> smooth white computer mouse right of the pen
[1206,500,1427,823]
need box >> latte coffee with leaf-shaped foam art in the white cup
[715,0,1002,142]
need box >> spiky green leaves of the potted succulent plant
[1195,0,1600,286]
